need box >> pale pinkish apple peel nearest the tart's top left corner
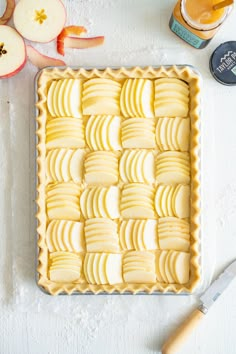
[26,45,66,69]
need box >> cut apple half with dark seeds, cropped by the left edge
[0,25,26,79]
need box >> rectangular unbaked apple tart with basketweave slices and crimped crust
[36,66,201,295]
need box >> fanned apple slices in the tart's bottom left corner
[49,252,82,283]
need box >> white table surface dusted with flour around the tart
[0,0,236,354]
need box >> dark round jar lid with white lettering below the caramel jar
[210,41,236,86]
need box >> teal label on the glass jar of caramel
[170,17,206,49]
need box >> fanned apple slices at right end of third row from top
[156,151,190,184]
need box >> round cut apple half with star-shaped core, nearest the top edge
[13,0,66,42]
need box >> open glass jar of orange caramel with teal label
[169,0,233,49]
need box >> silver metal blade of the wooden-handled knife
[199,260,236,314]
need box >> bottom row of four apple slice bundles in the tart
[49,250,190,285]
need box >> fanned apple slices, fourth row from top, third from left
[120,183,155,219]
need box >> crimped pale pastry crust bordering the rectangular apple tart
[36,66,201,295]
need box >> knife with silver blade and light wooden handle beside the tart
[162,260,236,354]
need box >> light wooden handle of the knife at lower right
[162,309,205,354]
